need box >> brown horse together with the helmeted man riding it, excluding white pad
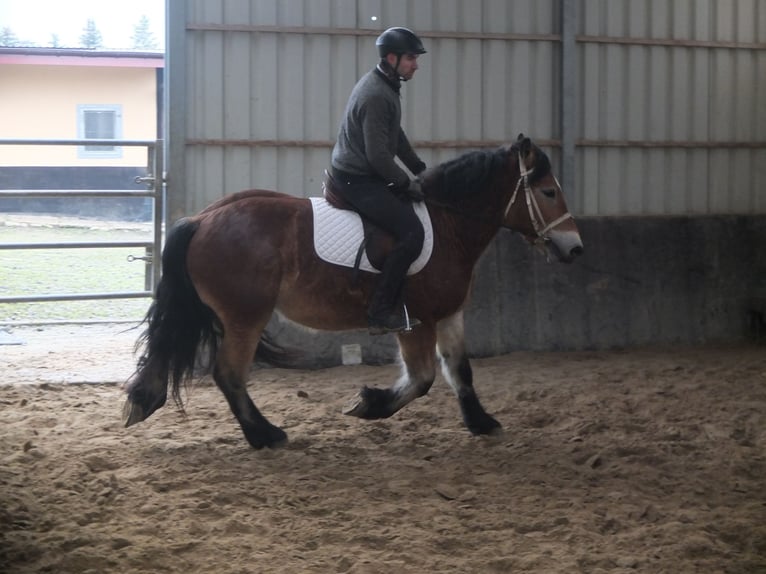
[123,28,583,449]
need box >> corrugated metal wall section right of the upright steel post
[576,0,766,215]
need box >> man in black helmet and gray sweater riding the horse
[331,28,426,334]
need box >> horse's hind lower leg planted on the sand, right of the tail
[213,328,287,449]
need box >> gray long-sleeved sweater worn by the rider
[332,68,425,187]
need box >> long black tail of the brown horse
[123,219,221,426]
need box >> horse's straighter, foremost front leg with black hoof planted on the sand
[436,310,500,434]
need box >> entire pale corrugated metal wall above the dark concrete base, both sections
[167,0,766,224]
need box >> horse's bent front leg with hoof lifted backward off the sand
[343,323,436,419]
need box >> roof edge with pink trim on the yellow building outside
[0,47,165,68]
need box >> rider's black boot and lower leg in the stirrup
[367,253,420,335]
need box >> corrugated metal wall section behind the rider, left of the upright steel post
[168,0,559,220]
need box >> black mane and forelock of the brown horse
[423,142,551,200]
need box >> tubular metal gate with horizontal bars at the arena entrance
[0,139,164,323]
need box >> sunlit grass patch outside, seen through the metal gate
[0,216,152,323]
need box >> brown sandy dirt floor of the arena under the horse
[0,326,766,574]
